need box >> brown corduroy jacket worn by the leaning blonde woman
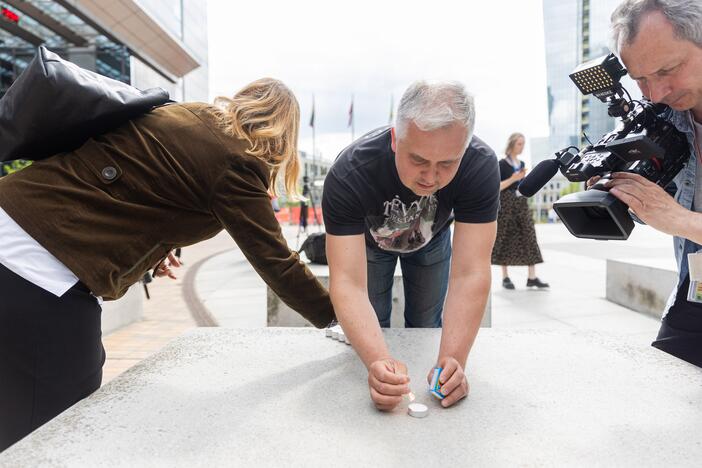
[0,103,334,327]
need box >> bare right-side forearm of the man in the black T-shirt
[439,266,491,368]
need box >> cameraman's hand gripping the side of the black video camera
[605,172,689,235]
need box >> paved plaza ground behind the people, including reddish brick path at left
[103,224,675,383]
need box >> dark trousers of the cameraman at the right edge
[651,276,702,367]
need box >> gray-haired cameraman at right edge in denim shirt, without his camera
[607,0,702,367]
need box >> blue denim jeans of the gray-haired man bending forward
[366,228,451,328]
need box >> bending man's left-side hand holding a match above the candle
[368,358,410,411]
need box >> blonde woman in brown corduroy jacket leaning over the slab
[0,78,334,451]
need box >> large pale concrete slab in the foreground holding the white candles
[5,328,702,467]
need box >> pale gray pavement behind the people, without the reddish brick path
[194,224,675,342]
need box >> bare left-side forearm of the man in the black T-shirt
[329,284,390,367]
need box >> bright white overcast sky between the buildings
[208,0,548,166]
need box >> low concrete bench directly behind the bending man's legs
[266,264,492,328]
